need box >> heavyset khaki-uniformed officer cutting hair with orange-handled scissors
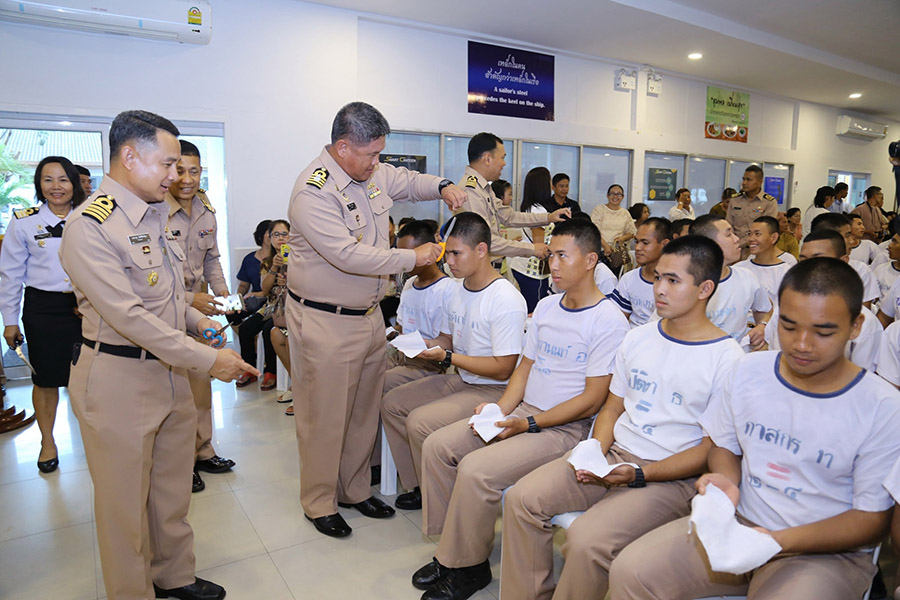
[286,102,465,537]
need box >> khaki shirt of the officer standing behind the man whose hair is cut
[457,165,550,256]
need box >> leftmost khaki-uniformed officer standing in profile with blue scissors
[60,111,255,600]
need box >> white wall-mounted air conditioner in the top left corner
[0,0,212,44]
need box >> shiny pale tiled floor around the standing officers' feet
[0,382,544,600]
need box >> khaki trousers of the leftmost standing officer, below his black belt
[69,346,197,600]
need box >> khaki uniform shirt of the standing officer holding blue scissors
[59,176,217,376]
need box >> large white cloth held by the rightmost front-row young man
[691,484,781,575]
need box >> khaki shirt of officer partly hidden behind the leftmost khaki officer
[166,190,228,304]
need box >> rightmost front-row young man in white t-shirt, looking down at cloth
[610,258,900,600]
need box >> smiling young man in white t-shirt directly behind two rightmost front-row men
[691,215,772,350]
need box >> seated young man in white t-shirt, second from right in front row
[500,236,743,600]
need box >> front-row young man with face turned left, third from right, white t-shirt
[412,220,628,600]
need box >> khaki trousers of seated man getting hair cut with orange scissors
[381,373,506,490]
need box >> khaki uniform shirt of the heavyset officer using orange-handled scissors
[287,148,443,309]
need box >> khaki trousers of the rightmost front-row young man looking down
[610,517,876,600]
